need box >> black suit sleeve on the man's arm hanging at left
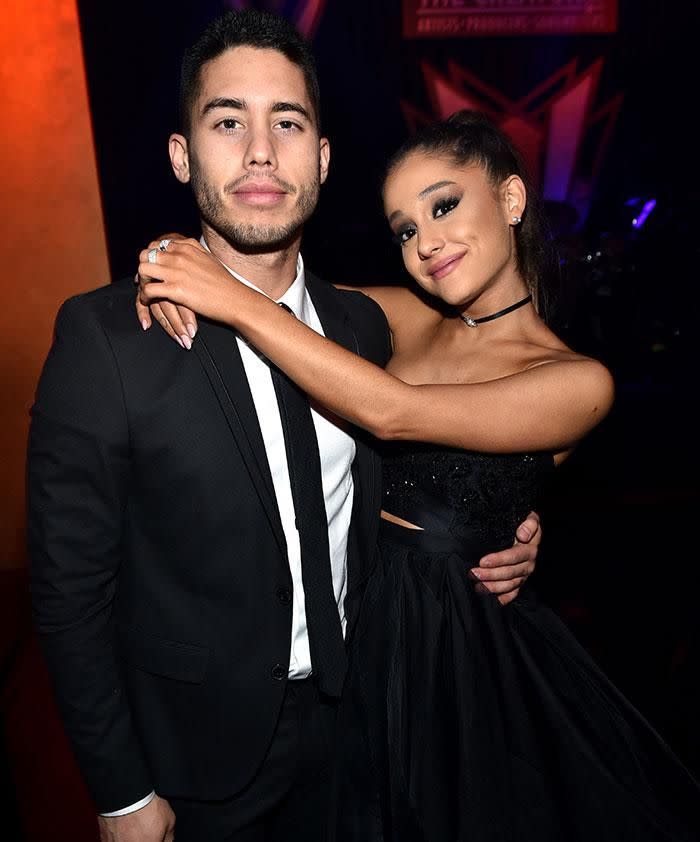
[27,297,153,812]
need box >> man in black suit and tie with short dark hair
[29,11,537,842]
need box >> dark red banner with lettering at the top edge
[403,0,617,38]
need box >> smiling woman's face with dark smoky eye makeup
[384,152,525,315]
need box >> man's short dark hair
[179,9,321,137]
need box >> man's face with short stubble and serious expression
[170,47,329,253]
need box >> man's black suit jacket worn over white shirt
[28,274,390,812]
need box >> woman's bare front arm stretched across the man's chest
[139,240,613,452]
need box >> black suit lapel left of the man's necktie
[193,319,287,554]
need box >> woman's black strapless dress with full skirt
[335,444,700,842]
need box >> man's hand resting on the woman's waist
[470,512,542,605]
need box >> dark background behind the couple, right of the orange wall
[74,0,700,766]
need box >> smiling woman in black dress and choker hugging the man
[134,112,700,842]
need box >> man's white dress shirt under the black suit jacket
[102,249,355,816]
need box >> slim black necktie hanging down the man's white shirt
[270,304,347,697]
